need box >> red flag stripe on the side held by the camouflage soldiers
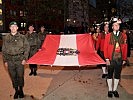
[27,35,60,65]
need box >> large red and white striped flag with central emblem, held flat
[27,34,105,66]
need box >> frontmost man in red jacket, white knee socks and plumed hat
[104,18,127,97]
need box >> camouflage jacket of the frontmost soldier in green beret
[2,33,30,62]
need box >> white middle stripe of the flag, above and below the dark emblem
[53,35,79,66]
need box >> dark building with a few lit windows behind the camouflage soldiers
[0,0,64,32]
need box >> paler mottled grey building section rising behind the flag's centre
[67,0,89,27]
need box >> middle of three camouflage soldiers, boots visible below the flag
[26,25,41,76]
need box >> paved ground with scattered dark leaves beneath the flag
[0,51,133,100]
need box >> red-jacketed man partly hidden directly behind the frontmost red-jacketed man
[96,23,109,78]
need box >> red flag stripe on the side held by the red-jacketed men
[76,34,105,66]
